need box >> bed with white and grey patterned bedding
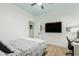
[0,38,48,56]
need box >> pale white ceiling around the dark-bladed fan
[16,3,79,16]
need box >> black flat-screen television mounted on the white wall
[45,22,62,33]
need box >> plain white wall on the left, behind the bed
[0,4,34,40]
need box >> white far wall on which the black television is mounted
[35,6,79,47]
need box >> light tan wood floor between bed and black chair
[46,45,68,56]
